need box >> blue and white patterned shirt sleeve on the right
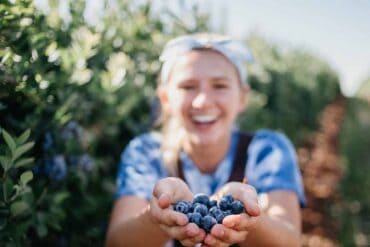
[246,130,306,206]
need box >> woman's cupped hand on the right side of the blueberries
[204,182,260,246]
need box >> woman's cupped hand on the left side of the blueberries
[149,177,206,246]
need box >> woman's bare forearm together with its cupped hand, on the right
[205,187,301,247]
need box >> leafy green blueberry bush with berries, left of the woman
[0,0,206,246]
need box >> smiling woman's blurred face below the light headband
[159,50,246,146]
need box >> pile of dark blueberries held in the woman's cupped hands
[174,194,244,233]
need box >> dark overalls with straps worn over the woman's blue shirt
[174,132,253,247]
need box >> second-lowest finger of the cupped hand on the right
[211,224,248,244]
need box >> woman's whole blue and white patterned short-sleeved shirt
[116,130,305,205]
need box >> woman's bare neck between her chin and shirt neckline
[184,134,231,173]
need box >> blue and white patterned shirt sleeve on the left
[115,134,163,200]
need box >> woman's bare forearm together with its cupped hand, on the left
[106,177,205,246]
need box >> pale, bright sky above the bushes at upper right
[155,0,370,96]
